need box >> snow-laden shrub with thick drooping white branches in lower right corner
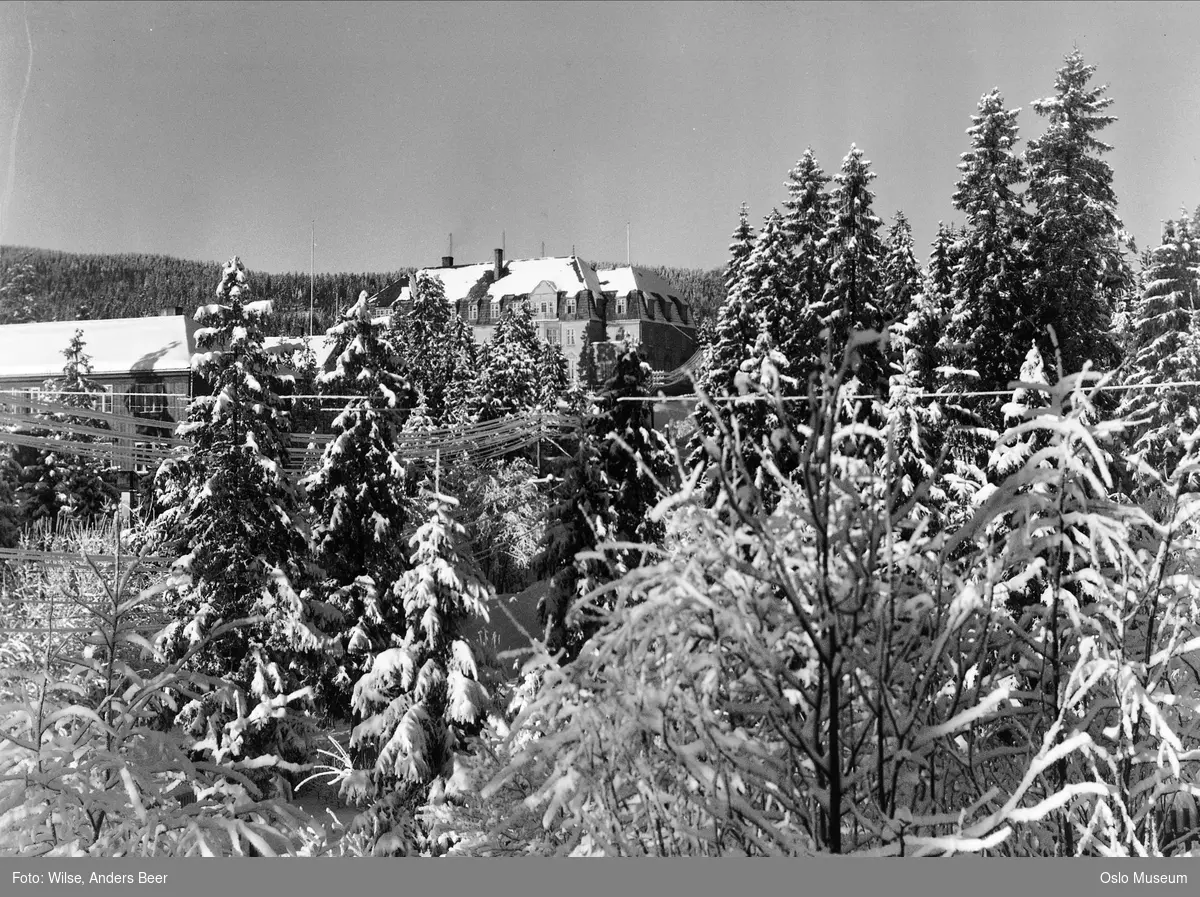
[974,359,1200,855]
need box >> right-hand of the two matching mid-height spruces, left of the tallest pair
[817,145,887,391]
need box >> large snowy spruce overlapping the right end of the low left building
[155,258,334,733]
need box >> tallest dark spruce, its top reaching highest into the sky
[1026,50,1133,372]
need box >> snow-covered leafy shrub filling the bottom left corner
[0,543,322,856]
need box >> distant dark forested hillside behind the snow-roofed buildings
[0,246,725,336]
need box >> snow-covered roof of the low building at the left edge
[0,315,196,378]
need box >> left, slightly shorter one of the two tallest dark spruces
[943,90,1040,400]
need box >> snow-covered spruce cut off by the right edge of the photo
[1118,217,1200,478]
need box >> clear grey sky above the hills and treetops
[0,0,1200,271]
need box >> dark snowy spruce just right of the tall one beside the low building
[302,291,414,715]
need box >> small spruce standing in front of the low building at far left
[14,330,118,526]
